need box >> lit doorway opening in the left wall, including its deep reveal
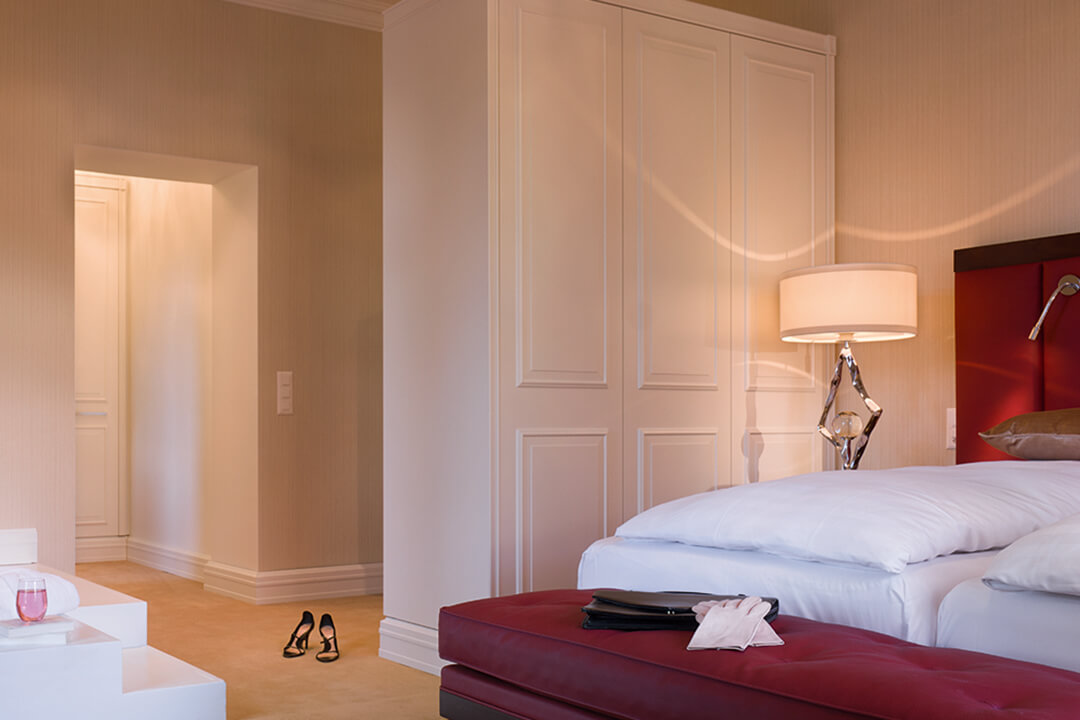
[75,147,258,581]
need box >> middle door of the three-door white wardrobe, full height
[623,11,731,517]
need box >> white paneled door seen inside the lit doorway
[75,173,125,538]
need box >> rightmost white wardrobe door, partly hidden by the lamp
[731,38,832,483]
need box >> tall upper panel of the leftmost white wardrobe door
[499,0,622,386]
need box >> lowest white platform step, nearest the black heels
[120,646,225,720]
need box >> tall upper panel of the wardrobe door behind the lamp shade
[732,38,829,391]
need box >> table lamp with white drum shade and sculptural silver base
[780,262,918,470]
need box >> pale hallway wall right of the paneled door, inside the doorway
[127,178,213,554]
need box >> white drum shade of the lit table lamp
[780,262,918,342]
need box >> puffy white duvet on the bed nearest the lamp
[616,461,1080,572]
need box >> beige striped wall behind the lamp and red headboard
[695,0,1080,467]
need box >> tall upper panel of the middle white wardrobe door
[624,13,731,390]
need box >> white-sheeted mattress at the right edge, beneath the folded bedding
[937,578,1080,673]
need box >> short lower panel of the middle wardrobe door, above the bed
[637,427,728,513]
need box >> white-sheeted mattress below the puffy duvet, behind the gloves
[578,538,996,644]
